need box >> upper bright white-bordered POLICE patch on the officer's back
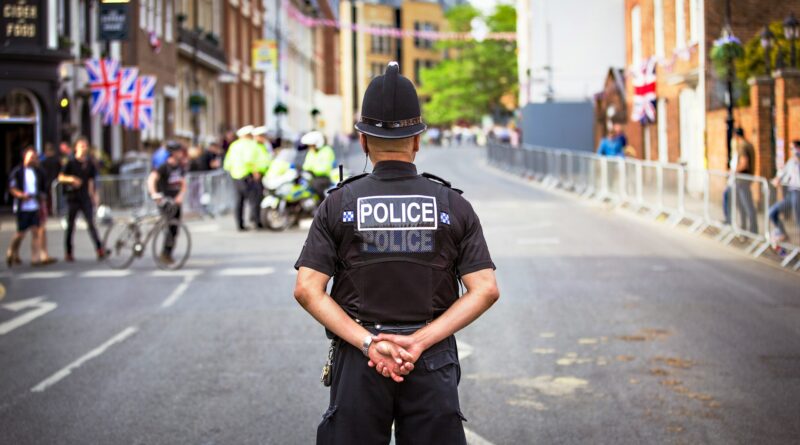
[356,195,438,231]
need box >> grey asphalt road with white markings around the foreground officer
[0,149,800,444]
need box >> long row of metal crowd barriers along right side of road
[487,143,800,270]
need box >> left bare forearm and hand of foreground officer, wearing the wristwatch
[294,267,414,382]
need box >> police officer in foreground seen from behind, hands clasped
[294,62,499,445]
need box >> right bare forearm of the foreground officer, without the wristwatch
[376,269,500,361]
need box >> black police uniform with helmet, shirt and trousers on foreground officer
[295,64,494,445]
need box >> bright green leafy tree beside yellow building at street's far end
[420,4,519,125]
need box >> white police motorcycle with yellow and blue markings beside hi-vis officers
[260,150,346,232]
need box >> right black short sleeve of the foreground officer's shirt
[450,193,496,275]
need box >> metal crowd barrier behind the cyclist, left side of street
[51,170,234,217]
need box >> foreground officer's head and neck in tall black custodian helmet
[356,62,426,159]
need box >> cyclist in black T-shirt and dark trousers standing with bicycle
[147,141,186,264]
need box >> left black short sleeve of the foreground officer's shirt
[294,194,338,276]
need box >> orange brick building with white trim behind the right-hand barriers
[625,0,800,180]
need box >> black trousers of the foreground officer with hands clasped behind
[317,331,466,445]
